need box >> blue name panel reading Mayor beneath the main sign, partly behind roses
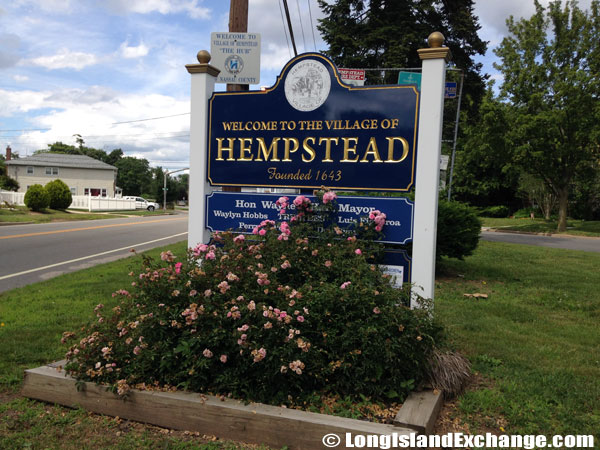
[206,192,414,244]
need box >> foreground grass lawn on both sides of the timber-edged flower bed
[0,242,600,449]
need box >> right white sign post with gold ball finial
[411,32,451,308]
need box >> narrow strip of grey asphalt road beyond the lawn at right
[481,231,600,252]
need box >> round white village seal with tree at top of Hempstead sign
[284,59,331,112]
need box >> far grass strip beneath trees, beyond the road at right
[482,217,600,237]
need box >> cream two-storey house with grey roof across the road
[5,149,117,197]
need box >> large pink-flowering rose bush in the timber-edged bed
[64,193,441,404]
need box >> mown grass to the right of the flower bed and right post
[435,242,600,439]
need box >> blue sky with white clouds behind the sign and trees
[0,0,591,170]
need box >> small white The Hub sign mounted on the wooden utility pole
[210,32,260,84]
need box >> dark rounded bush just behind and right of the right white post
[436,199,481,259]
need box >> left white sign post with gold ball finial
[185,50,220,247]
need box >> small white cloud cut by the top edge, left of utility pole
[107,0,211,19]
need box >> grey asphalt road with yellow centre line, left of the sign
[0,214,188,292]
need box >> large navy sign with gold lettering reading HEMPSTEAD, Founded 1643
[206,53,419,191]
